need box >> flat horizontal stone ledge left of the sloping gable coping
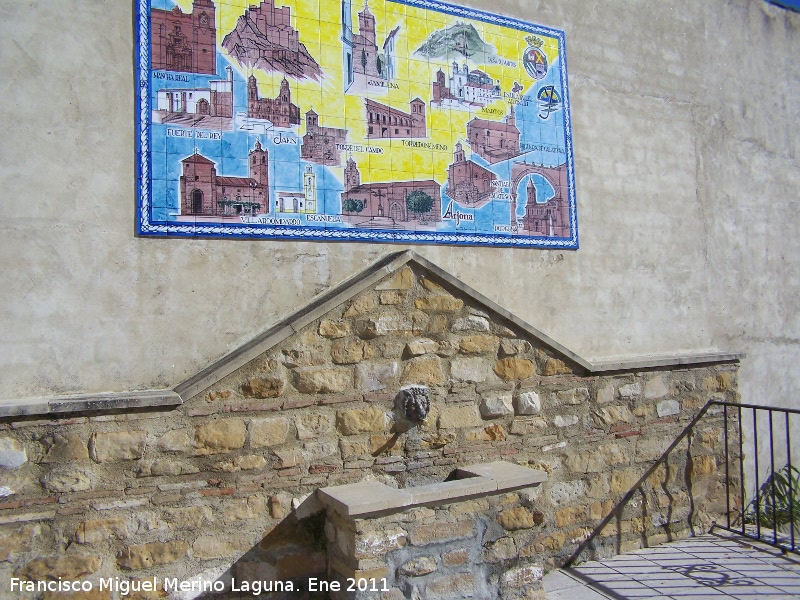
[0,390,183,418]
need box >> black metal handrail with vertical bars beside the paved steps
[564,400,800,567]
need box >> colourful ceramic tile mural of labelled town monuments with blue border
[136,0,578,248]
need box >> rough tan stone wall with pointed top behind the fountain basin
[0,263,738,598]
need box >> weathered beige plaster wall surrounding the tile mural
[0,0,800,412]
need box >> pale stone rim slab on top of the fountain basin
[317,461,547,517]
